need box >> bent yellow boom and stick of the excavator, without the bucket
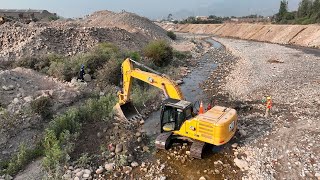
[118,58,184,105]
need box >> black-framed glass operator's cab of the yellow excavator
[160,98,193,132]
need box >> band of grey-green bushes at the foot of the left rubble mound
[15,43,120,81]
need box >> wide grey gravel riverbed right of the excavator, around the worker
[215,38,320,179]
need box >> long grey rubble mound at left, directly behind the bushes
[0,23,147,61]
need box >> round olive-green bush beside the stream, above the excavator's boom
[143,40,173,67]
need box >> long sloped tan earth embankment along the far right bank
[162,23,320,48]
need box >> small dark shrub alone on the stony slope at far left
[31,96,52,119]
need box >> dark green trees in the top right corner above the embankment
[276,0,320,24]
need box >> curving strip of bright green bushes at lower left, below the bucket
[43,94,116,175]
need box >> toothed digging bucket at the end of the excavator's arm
[114,102,141,121]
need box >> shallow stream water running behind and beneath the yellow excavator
[144,39,241,180]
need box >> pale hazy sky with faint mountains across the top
[0,0,300,19]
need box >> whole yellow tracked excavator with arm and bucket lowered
[115,58,238,159]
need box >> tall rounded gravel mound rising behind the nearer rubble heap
[86,11,169,40]
